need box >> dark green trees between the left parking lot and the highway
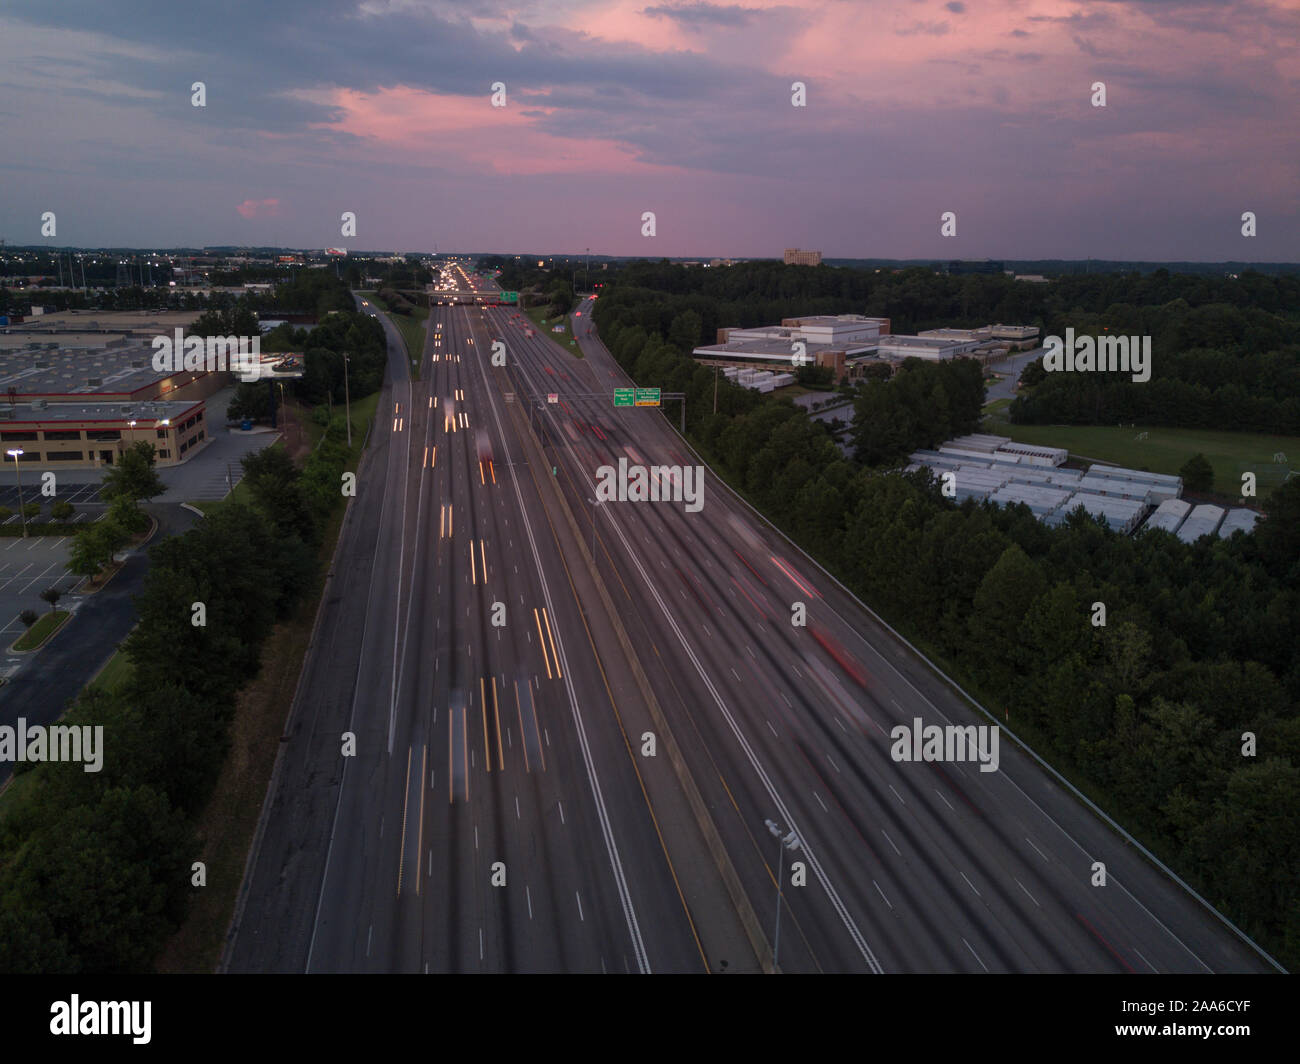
[0,418,350,973]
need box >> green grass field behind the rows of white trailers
[982,418,1300,497]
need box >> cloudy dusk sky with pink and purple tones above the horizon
[0,0,1300,261]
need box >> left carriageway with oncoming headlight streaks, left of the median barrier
[224,269,758,972]
